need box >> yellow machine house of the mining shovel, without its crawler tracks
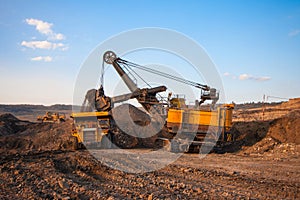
[166,104,234,149]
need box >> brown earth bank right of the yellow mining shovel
[230,111,300,157]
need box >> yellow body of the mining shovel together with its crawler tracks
[165,104,234,151]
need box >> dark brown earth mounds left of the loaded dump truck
[0,114,71,153]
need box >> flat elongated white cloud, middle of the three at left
[21,40,66,50]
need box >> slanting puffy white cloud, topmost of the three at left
[25,18,65,40]
